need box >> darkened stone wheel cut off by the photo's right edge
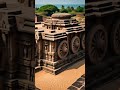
[111,19,120,55]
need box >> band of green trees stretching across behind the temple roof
[35,4,85,16]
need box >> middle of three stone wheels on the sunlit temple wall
[71,36,80,53]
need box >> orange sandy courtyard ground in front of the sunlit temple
[35,59,85,90]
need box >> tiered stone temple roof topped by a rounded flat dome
[36,13,83,41]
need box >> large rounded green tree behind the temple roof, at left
[38,4,59,16]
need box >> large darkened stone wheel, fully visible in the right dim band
[86,24,108,64]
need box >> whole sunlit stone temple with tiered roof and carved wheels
[35,13,85,74]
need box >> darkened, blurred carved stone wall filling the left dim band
[0,2,35,90]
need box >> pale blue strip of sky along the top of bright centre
[35,0,85,4]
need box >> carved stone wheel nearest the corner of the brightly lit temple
[58,40,69,58]
